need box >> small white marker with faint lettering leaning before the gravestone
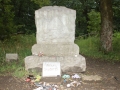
[42,62,61,77]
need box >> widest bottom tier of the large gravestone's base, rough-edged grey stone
[25,55,86,73]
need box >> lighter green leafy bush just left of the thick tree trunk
[87,10,101,35]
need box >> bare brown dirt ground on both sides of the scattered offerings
[0,57,120,90]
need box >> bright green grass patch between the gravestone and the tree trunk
[75,37,99,57]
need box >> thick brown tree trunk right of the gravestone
[100,0,113,53]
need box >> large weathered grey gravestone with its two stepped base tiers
[25,6,86,72]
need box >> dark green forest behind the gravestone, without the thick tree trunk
[0,0,120,37]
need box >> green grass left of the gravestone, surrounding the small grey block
[0,34,36,73]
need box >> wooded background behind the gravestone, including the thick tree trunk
[0,0,120,52]
